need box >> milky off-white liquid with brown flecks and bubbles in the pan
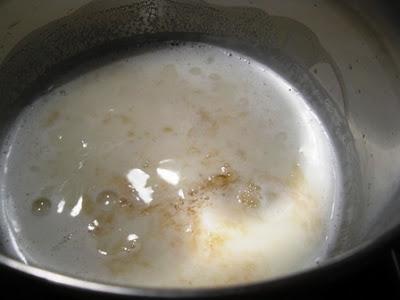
[2,44,338,287]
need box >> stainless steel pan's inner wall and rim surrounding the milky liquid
[0,0,400,297]
